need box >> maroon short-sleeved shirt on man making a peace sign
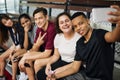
[34,22,56,51]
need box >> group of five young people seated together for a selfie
[0,5,120,80]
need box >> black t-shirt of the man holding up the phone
[75,29,114,80]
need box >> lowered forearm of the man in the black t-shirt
[47,61,82,80]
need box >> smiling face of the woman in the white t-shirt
[58,15,72,33]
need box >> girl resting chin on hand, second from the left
[11,14,36,80]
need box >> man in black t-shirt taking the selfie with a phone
[47,5,120,80]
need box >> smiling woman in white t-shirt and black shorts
[35,12,80,80]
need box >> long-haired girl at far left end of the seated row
[0,14,21,80]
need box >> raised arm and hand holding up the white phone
[105,5,120,42]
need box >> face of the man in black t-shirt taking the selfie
[72,16,90,36]
